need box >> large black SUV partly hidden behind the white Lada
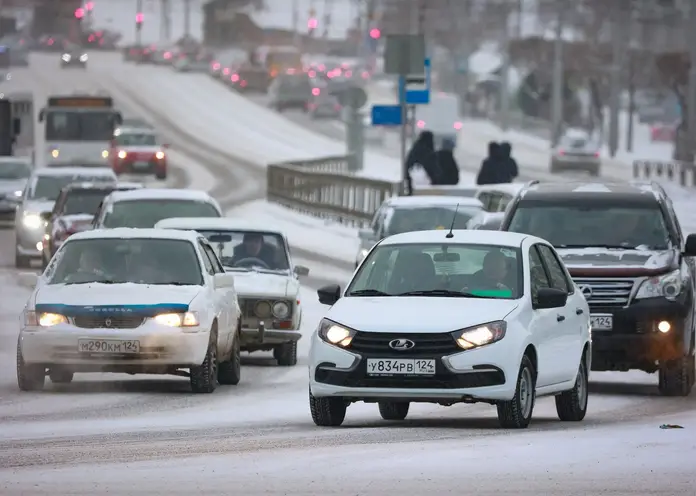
[501,182,696,396]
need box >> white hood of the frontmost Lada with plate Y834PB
[326,296,519,333]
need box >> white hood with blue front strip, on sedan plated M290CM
[36,283,201,311]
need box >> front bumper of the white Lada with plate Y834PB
[309,333,521,404]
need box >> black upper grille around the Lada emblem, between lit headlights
[349,331,462,357]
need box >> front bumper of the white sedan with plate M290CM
[20,317,210,372]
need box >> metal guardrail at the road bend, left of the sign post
[266,156,399,226]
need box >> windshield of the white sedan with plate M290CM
[46,238,203,286]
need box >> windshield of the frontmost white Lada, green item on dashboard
[347,243,524,299]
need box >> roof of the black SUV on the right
[522,181,662,203]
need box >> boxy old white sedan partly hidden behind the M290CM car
[156,217,309,366]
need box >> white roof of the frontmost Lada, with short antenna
[380,229,548,247]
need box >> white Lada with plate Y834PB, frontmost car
[309,231,591,428]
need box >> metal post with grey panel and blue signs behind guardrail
[380,34,430,195]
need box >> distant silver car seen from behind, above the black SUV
[549,131,602,176]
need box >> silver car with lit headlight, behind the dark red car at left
[14,167,117,268]
